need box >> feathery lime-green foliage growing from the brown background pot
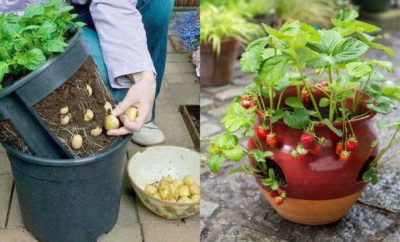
[200,3,262,54]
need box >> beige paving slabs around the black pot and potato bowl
[0,10,200,242]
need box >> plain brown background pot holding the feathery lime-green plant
[200,39,239,86]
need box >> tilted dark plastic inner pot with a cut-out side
[0,30,89,159]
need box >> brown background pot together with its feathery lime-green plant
[200,2,260,86]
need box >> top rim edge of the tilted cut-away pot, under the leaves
[0,29,83,99]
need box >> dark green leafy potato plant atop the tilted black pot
[0,0,84,90]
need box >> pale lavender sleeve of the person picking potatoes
[89,0,155,83]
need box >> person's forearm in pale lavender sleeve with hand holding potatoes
[90,0,156,135]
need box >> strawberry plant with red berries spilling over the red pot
[208,9,400,193]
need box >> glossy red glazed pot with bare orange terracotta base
[248,88,377,225]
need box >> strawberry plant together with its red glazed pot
[208,9,400,225]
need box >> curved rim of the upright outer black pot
[4,135,131,167]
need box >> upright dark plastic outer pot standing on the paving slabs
[5,136,130,242]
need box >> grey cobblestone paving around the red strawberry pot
[200,33,400,242]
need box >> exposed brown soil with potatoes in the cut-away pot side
[34,58,117,157]
